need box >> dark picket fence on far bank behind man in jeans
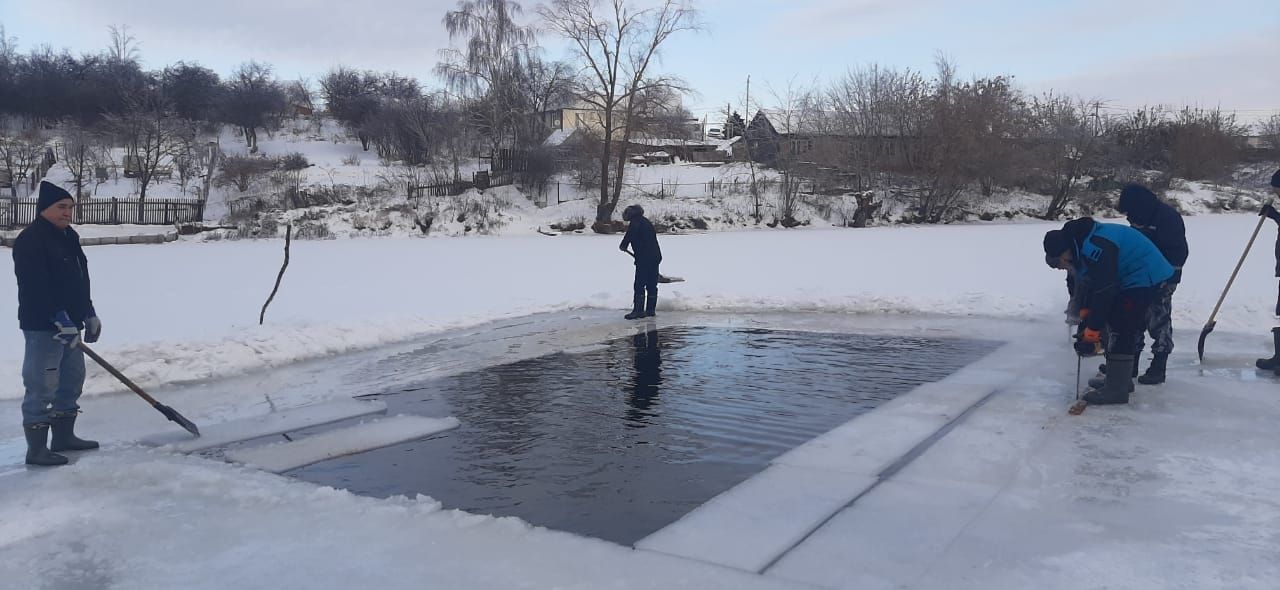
[0,198,205,228]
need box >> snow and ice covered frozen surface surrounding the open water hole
[0,215,1280,589]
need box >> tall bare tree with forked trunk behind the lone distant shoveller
[539,0,698,232]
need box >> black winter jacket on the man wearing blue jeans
[13,216,96,330]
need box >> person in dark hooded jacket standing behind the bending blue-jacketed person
[1116,184,1189,385]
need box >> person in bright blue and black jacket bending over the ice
[1044,218,1174,404]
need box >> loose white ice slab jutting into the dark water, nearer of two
[227,416,458,474]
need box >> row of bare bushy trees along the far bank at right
[747,56,1265,223]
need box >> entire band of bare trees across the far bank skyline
[0,0,1280,230]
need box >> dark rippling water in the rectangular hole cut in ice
[293,323,988,544]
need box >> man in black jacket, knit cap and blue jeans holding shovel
[13,182,102,466]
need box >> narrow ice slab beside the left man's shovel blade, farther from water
[142,399,387,453]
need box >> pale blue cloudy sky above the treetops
[0,0,1280,119]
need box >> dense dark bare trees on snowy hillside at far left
[0,27,296,200]
